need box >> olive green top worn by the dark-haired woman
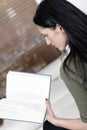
[60,59,87,122]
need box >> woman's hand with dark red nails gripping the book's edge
[45,99,56,124]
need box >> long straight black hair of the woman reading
[33,0,87,81]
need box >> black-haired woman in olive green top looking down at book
[33,0,87,130]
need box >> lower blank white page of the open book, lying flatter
[0,99,45,123]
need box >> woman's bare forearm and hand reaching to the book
[46,99,87,130]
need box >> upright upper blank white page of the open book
[6,71,51,104]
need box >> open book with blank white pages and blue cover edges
[0,71,51,123]
